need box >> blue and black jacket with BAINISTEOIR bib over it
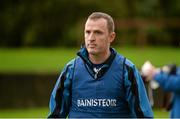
[49,48,153,118]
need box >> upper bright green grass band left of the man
[0,48,77,73]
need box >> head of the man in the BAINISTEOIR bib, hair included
[84,12,115,55]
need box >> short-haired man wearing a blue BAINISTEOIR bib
[49,12,153,118]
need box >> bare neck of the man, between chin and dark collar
[89,50,111,64]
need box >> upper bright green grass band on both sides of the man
[0,47,180,73]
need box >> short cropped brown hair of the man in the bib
[88,12,115,32]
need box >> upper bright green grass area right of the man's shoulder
[118,47,180,67]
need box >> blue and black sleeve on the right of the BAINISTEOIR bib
[124,60,153,118]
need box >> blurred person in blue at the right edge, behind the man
[145,62,180,118]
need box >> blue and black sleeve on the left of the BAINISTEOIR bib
[48,59,73,118]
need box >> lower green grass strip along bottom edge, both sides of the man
[0,108,169,118]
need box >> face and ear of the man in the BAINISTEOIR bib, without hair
[84,18,115,55]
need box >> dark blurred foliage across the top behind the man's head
[0,0,180,47]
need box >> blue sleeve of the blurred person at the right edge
[154,72,180,92]
